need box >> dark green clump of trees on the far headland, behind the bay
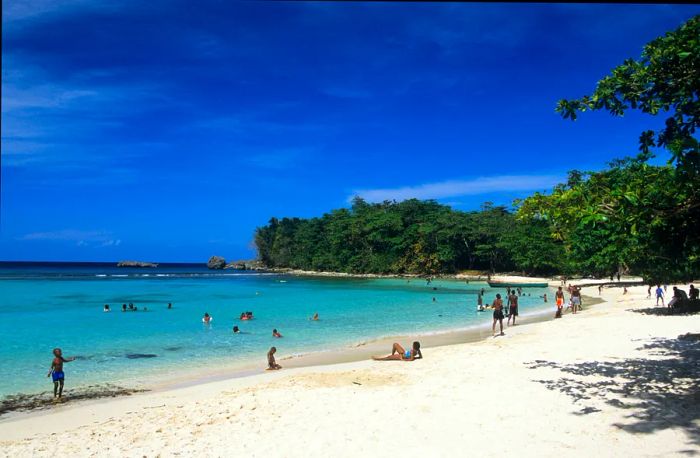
[255,198,561,274]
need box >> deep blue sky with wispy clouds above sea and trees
[0,0,700,262]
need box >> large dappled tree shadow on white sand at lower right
[526,334,700,448]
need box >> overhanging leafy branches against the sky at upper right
[556,16,700,173]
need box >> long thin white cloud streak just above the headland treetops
[348,175,563,202]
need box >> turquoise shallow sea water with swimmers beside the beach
[0,263,551,397]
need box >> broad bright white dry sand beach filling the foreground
[0,287,700,457]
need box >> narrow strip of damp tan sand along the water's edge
[0,295,604,426]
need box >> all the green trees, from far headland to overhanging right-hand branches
[255,16,700,282]
